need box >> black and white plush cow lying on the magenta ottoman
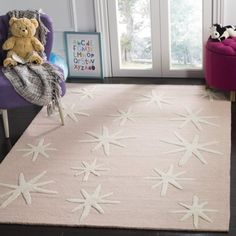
[210,24,236,42]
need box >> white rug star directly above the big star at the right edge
[170,107,218,130]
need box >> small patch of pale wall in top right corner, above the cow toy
[224,0,236,25]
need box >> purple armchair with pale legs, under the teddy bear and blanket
[0,14,66,138]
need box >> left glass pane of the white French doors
[117,0,152,69]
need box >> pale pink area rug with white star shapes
[0,84,231,231]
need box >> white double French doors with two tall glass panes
[107,0,212,77]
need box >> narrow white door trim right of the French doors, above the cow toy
[212,0,225,25]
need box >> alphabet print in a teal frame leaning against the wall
[65,32,103,79]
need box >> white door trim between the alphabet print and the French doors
[94,0,112,77]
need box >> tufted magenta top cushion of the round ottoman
[206,37,236,56]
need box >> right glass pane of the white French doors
[169,0,202,69]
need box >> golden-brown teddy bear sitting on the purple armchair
[2,17,44,67]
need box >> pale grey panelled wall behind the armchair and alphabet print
[0,0,95,56]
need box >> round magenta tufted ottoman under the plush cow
[205,37,236,100]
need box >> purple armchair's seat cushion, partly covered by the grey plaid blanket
[0,66,66,109]
